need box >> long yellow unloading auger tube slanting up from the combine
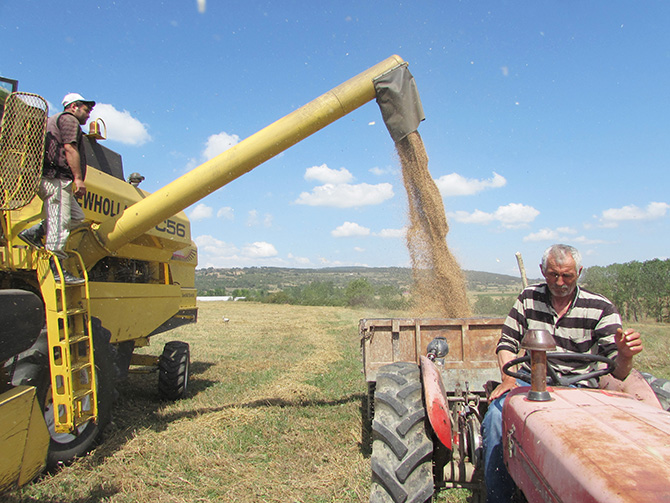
[78,55,423,268]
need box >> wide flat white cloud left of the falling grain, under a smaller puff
[295,183,393,208]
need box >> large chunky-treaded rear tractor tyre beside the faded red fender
[370,362,434,503]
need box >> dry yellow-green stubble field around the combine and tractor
[3,302,670,503]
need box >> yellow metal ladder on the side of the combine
[38,251,98,433]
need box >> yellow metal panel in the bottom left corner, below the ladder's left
[0,386,49,491]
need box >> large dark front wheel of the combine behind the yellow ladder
[43,318,114,469]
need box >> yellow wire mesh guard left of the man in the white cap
[0,93,49,210]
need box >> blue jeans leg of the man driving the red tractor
[482,383,527,503]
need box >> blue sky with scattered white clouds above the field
[0,0,670,277]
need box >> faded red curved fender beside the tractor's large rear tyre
[421,356,452,450]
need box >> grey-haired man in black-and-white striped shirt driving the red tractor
[482,244,642,503]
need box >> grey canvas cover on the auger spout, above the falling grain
[373,64,426,143]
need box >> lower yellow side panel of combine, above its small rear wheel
[89,282,182,342]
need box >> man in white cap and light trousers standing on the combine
[19,93,95,285]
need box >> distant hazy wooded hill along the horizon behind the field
[195,267,536,293]
